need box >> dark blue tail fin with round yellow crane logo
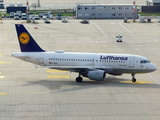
[15,24,45,52]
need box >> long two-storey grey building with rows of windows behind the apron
[75,4,137,19]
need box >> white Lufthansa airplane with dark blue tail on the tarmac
[12,24,157,82]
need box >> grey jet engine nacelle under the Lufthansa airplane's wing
[87,70,106,81]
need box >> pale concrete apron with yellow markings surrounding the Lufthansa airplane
[0,19,160,120]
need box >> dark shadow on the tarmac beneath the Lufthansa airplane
[22,78,160,93]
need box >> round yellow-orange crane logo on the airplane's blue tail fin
[19,32,30,44]
